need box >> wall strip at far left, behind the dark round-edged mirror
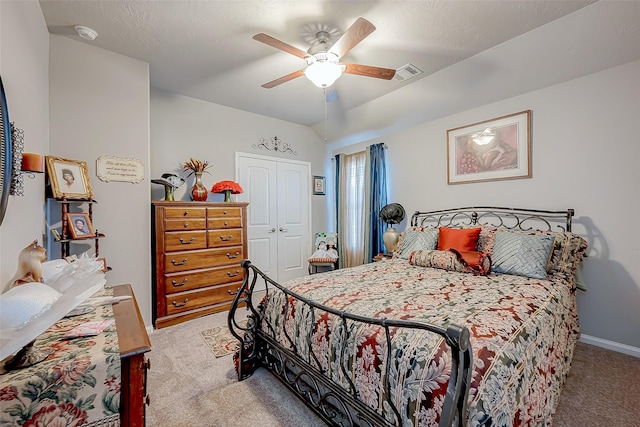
[0,1,49,289]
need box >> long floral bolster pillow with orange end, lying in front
[409,249,491,275]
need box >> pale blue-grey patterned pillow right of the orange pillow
[491,231,555,279]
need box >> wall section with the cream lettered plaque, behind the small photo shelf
[49,35,151,325]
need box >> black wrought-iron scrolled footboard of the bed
[228,260,472,427]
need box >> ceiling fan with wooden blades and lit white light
[253,18,396,93]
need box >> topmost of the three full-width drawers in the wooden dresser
[164,246,244,273]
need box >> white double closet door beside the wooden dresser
[236,153,311,283]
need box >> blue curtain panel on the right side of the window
[368,143,387,262]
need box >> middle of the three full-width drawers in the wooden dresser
[164,264,244,294]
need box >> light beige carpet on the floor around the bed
[147,310,640,427]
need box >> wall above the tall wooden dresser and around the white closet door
[151,89,327,233]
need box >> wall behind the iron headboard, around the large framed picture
[335,61,640,349]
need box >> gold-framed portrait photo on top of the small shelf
[47,156,93,200]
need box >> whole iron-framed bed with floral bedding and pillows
[228,207,587,426]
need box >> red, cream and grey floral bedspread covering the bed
[262,259,579,427]
